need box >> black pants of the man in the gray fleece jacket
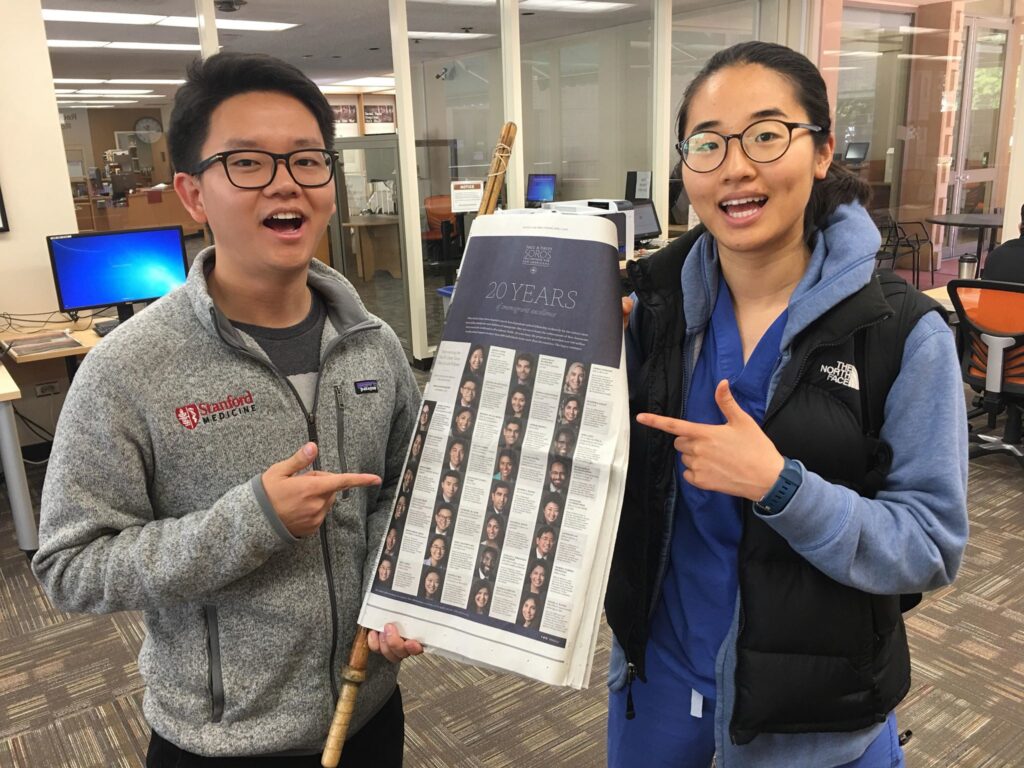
[145,686,406,768]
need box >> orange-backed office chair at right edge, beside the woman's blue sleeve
[946,280,1024,468]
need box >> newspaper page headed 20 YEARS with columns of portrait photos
[359,212,629,688]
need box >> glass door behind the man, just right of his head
[331,134,413,356]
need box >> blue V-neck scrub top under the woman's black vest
[648,278,787,696]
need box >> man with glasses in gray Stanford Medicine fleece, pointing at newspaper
[33,53,422,768]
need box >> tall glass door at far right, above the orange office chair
[948,18,1009,225]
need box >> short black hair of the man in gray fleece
[167,51,334,173]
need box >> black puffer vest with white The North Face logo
[606,236,938,743]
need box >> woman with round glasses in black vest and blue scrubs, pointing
[605,42,968,768]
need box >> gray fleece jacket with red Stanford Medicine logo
[33,249,419,756]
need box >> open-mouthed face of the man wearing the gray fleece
[174,91,334,281]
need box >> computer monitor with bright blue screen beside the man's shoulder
[46,226,187,322]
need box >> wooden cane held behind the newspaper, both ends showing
[321,122,516,768]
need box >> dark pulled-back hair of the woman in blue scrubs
[676,41,871,243]
